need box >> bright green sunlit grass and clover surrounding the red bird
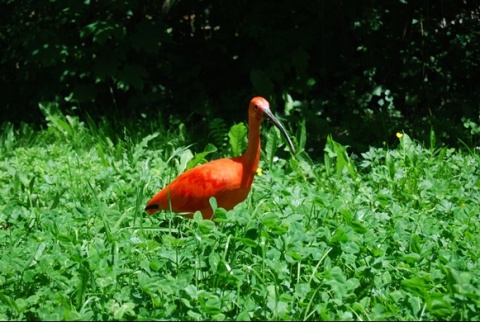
[0,109,480,320]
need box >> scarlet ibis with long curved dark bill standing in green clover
[145,97,295,219]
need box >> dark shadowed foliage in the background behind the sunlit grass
[0,0,480,156]
